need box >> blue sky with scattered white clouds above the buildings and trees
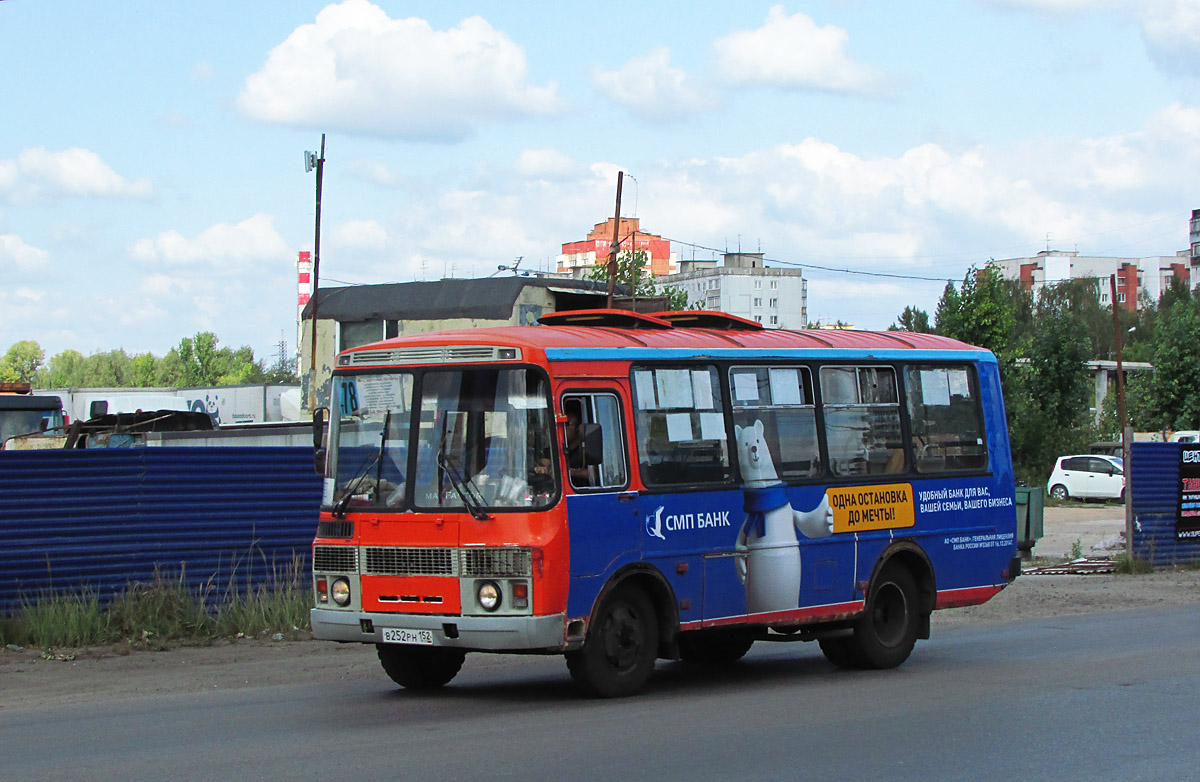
[0,0,1200,356]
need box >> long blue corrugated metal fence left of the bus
[0,447,320,610]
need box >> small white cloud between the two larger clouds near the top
[592,47,714,122]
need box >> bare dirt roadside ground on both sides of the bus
[0,504,1200,712]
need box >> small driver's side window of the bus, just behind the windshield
[563,393,629,489]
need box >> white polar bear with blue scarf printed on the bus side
[733,421,833,614]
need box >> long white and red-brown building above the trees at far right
[994,250,1200,312]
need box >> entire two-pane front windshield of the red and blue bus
[330,368,559,515]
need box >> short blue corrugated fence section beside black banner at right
[1129,443,1200,567]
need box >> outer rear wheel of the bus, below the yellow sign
[853,565,920,669]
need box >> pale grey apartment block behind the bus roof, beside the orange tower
[655,253,809,329]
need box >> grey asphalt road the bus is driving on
[0,607,1200,782]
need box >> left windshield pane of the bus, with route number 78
[330,373,413,511]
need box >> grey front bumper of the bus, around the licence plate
[310,608,566,651]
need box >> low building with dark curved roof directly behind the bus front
[300,277,607,409]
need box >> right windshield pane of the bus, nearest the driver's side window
[413,368,559,513]
